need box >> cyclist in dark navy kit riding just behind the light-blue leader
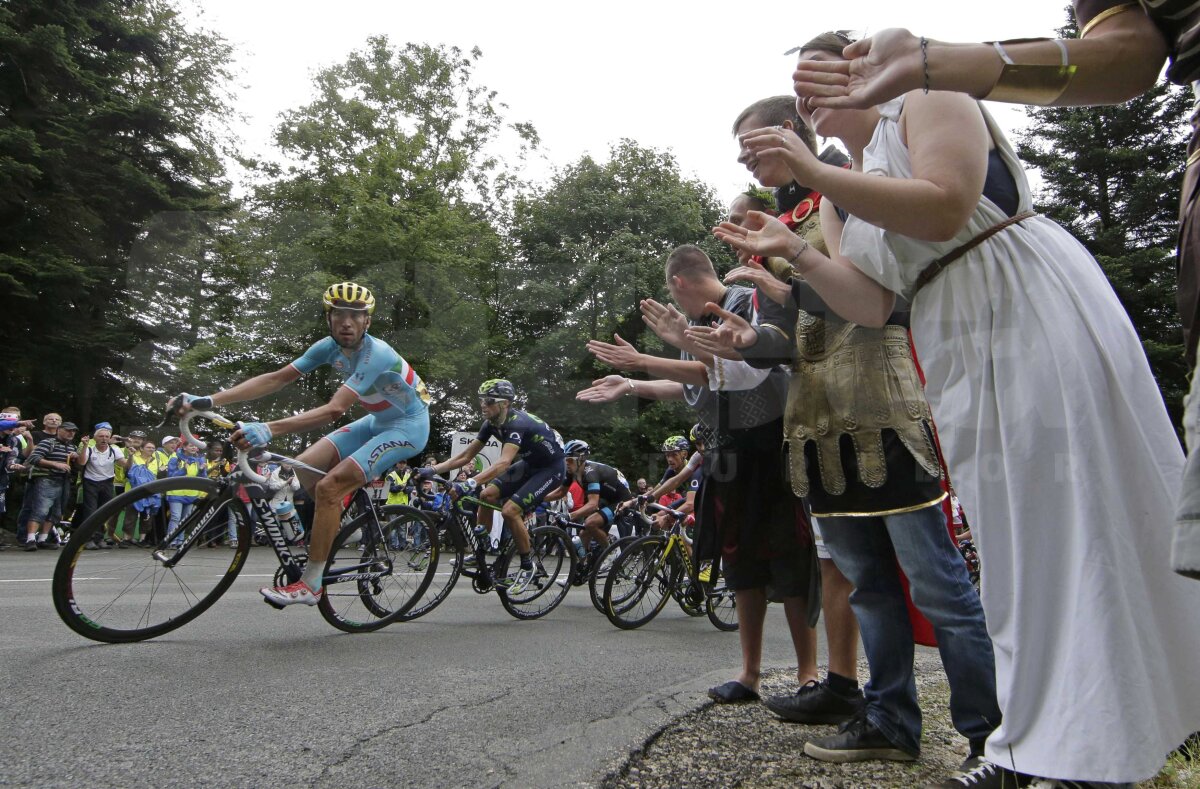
[419,378,566,594]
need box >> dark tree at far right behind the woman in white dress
[1016,12,1192,427]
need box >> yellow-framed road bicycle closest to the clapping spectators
[604,504,738,631]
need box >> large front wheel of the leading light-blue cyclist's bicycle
[50,477,250,643]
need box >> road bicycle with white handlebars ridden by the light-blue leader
[52,411,437,643]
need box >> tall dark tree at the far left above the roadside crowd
[0,0,230,423]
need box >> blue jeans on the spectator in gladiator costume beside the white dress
[820,505,1000,753]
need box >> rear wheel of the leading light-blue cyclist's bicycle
[318,510,438,633]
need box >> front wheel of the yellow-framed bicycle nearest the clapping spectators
[604,535,676,630]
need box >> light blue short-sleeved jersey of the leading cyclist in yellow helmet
[292,335,430,420]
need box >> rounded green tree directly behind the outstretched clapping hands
[508,139,732,475]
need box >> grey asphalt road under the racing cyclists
[0,548,823,787]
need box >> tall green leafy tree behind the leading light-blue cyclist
[181,36,538,455]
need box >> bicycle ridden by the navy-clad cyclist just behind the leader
[400,476,576,619]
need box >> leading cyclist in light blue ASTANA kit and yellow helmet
[173,282,430,606]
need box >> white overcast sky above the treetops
[190,0,1067,200]
